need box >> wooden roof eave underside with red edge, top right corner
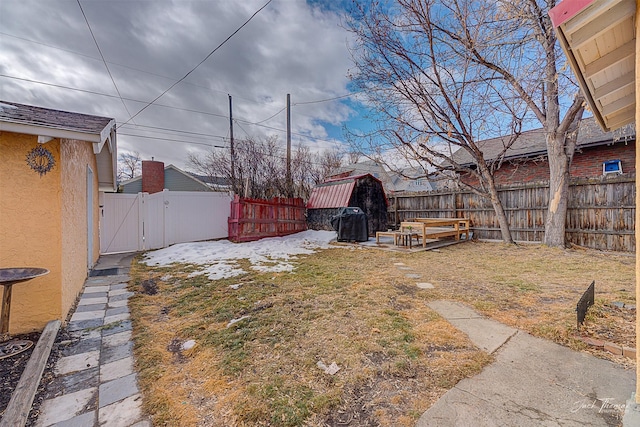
[549,0,636,131]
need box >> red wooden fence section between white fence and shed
[229,195,307,242]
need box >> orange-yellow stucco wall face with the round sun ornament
[0,132,62,334]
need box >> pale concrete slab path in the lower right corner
[417,301,635,427]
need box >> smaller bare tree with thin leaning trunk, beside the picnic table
[349,0,526,243]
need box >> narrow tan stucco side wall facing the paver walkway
[60,139,99,315]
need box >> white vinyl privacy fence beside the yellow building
[100,190,232,254]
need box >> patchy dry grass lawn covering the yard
[130,242,635,426]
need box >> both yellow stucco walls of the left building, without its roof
[0,132,100,334]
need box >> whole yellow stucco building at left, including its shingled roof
[0,101,117,334]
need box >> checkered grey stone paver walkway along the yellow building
[36,274,151,427]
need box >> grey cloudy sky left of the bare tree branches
[0,0,367,170]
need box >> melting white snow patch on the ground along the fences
[142,230,336,280]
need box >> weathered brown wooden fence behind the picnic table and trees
[389,176,636,252]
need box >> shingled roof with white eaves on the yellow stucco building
[0,101,117,191]
